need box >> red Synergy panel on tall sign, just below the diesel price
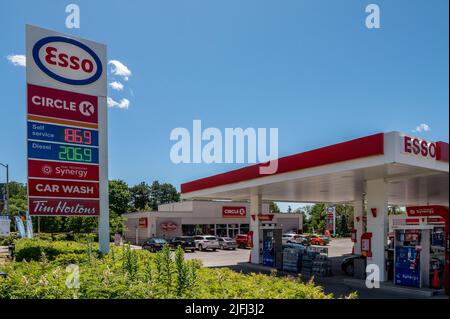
[28,160,99,181]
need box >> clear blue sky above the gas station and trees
[0,0,449,212]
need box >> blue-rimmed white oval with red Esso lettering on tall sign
[33,36,103,85]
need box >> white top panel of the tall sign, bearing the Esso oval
[26,25,107,97]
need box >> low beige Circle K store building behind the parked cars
[124,200,303,244]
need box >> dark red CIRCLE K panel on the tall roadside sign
[28,84,98,123]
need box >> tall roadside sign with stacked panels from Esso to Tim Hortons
[26,26,108,216]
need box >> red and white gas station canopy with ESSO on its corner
[181,132,449,206]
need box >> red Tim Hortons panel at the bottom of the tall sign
[28,197,100,216]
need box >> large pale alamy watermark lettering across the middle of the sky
[170,120,278,174]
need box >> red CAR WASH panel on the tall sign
[28,179,99,198]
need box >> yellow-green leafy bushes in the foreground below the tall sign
[0,240,344,299]
